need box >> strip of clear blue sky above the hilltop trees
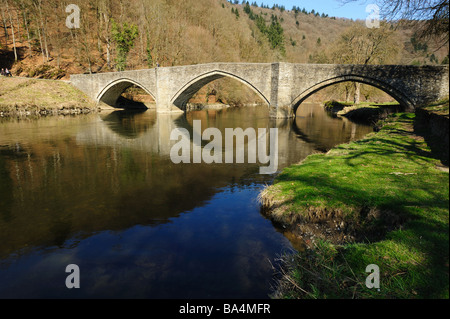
[251,0,370,20]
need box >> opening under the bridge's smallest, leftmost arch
[97,79,156,109]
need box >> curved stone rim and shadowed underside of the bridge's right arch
[291,75,414,114]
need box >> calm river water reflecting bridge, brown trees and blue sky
[0,104,372,298]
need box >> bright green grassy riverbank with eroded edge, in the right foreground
[261,108,449,298]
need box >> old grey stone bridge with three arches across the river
[70,62,449,118]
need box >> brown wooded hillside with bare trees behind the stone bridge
[0,0,448,104]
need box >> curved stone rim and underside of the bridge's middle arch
[171,70,270,110]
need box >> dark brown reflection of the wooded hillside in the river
[0,112,268,257]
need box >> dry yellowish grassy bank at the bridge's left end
[0,77,96,117]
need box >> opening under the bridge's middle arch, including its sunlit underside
[172,71,269,110]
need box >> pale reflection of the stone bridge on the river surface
[76,106,368,166]
